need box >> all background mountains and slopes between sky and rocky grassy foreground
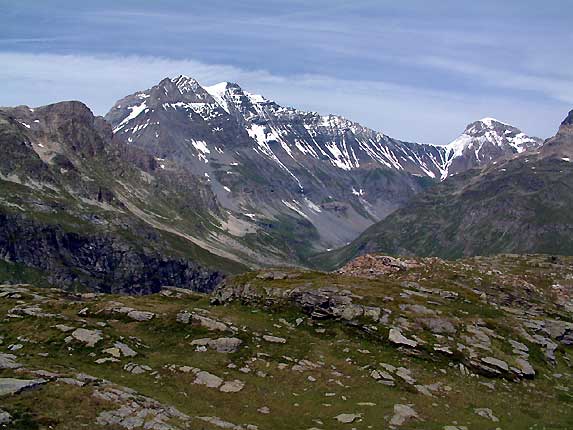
[0,76,571,292]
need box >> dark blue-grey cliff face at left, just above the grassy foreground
[0,214,222,294]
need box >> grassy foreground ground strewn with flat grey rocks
[0,255,573,430]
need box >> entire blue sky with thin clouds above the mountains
[0,0,573,144]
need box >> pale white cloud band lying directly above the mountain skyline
[0,52,567,144]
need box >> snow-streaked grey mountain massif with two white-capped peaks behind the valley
[101,76,541,261]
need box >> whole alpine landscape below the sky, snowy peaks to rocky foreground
[0,76,573,430]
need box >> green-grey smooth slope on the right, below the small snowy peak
[310,156,573,269]
